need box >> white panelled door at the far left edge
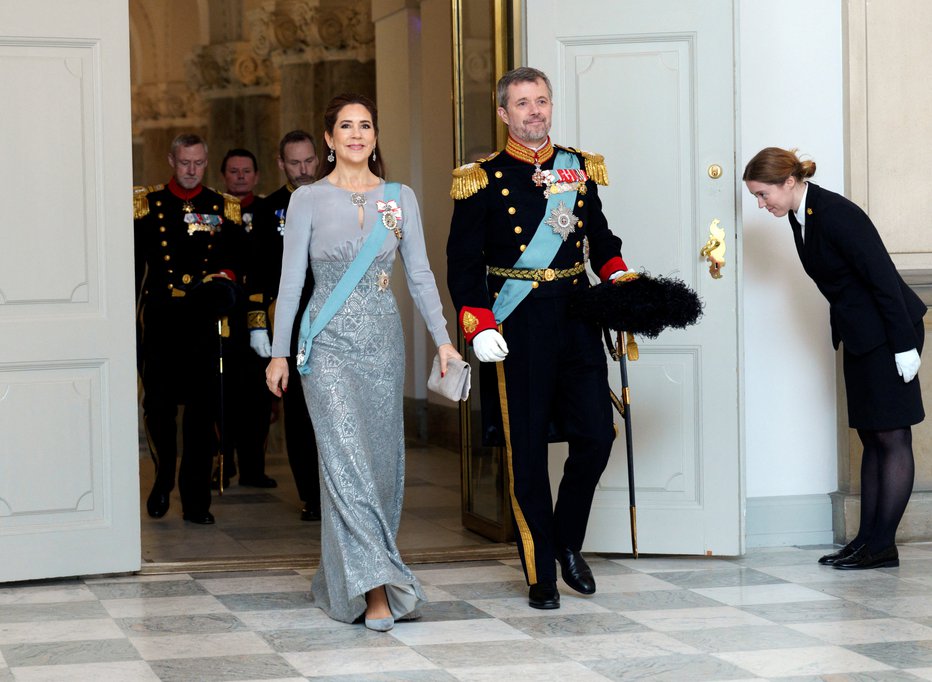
[0,0,140,581]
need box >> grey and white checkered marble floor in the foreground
[0,544,932,682]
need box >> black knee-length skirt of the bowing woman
[844,322,925,431]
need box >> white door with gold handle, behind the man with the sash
[527,0,743,554]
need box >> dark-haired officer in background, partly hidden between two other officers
[211,148,277,489]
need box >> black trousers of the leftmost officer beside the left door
[142,298,220,514]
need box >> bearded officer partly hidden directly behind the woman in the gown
[246,130,320,521]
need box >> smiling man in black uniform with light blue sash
[447,67,627,609]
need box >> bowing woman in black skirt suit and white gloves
[743,147,926,569]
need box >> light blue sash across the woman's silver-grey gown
[296,182,401,374]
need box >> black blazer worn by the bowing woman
[787,182,927,355]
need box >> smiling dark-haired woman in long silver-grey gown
[266,95,460,631]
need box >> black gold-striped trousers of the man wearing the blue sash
[496,296,615,585]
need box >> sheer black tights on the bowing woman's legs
[851,426,916,552]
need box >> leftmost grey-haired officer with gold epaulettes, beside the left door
[133,135,240,524]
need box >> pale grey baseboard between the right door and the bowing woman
[745,493,833,548]
